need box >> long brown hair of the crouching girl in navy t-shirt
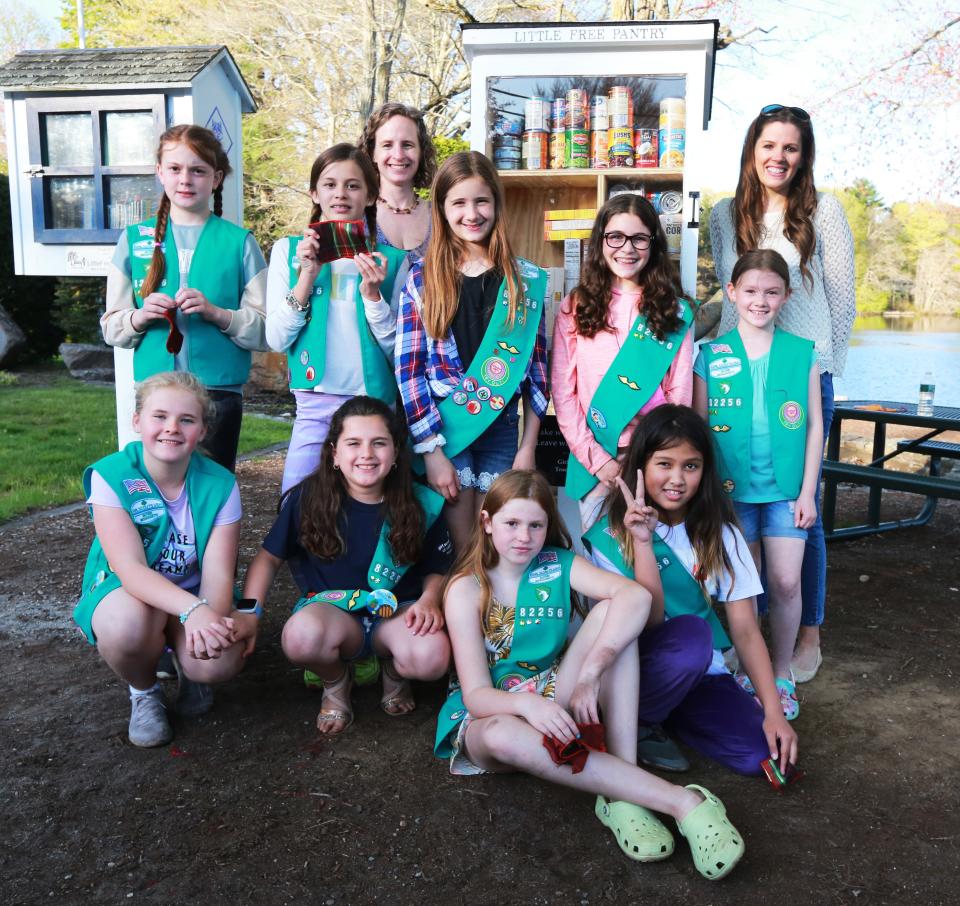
[294,396,426,564]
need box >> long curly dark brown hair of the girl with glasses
[571,192,683,340]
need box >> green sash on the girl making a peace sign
[583,515,730,649]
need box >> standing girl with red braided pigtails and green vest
[100,125,267,470]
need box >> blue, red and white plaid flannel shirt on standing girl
[394,262,549,443]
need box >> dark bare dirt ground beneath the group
[0,434,960,906]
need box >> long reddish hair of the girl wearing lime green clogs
[443,469,573,613]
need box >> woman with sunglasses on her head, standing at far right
[710,104,856,683]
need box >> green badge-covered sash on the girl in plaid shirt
[414,258,547,475]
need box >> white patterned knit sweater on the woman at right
[710,192,857,375]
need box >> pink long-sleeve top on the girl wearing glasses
[550,289,693,474]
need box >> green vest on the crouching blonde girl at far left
[73,441,236,645]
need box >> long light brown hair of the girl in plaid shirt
[422,151,521,340]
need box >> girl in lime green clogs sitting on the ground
[435,470,744,879]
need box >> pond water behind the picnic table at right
[834,316,960,406]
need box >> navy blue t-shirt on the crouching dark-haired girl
[263,487,453,603]
